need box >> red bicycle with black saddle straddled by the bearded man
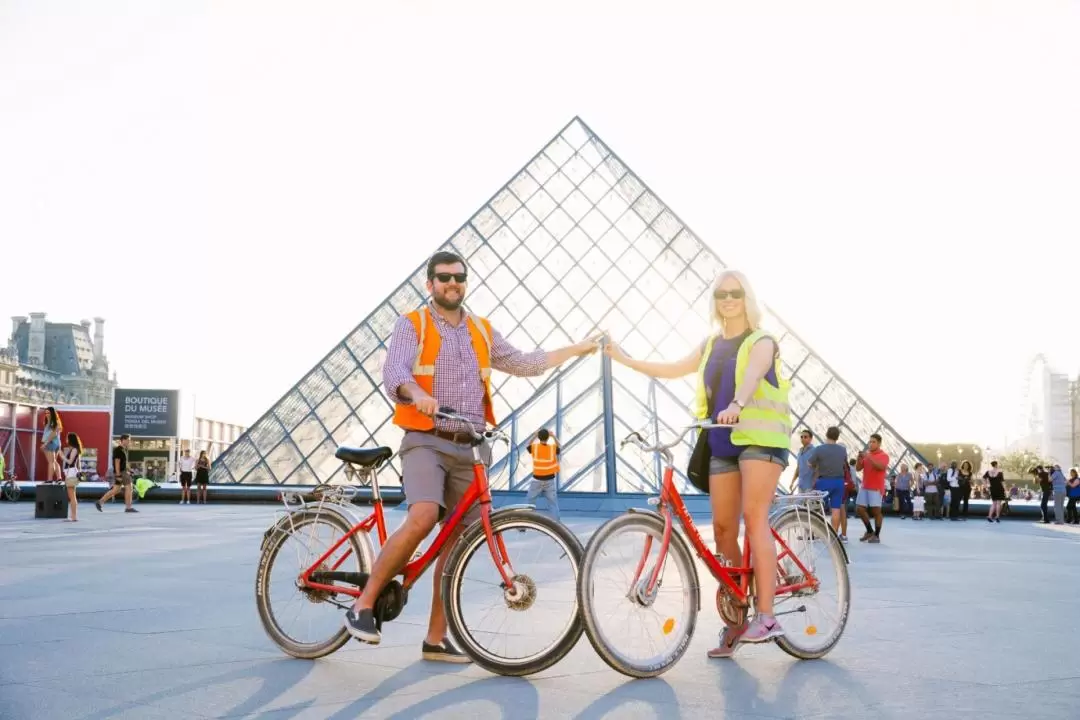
[255,408,583,676]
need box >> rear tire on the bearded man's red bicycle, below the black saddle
[255,510,370,660]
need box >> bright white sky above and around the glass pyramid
[0,0,1080,444]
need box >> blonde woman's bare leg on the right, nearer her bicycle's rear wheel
[739,460,783,615]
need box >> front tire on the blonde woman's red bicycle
[578,513,701,678]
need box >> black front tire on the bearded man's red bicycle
[442,510,584,677]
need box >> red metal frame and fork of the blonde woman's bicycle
[631,464,818,604]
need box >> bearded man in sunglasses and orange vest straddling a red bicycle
[345,252,599,663]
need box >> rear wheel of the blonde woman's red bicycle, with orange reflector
[772,512,851,660]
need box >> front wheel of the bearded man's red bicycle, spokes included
[442,510,583,676]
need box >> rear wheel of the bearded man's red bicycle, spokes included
[255,510,370,660]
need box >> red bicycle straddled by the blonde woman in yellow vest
[578,422,850,678]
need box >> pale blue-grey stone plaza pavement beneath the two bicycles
[0,502,1080,720]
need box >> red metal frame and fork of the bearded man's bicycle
[300,445,514,597]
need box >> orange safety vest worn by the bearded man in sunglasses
[393,307,498,431]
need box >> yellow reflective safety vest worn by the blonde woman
[690,330,792,449]
